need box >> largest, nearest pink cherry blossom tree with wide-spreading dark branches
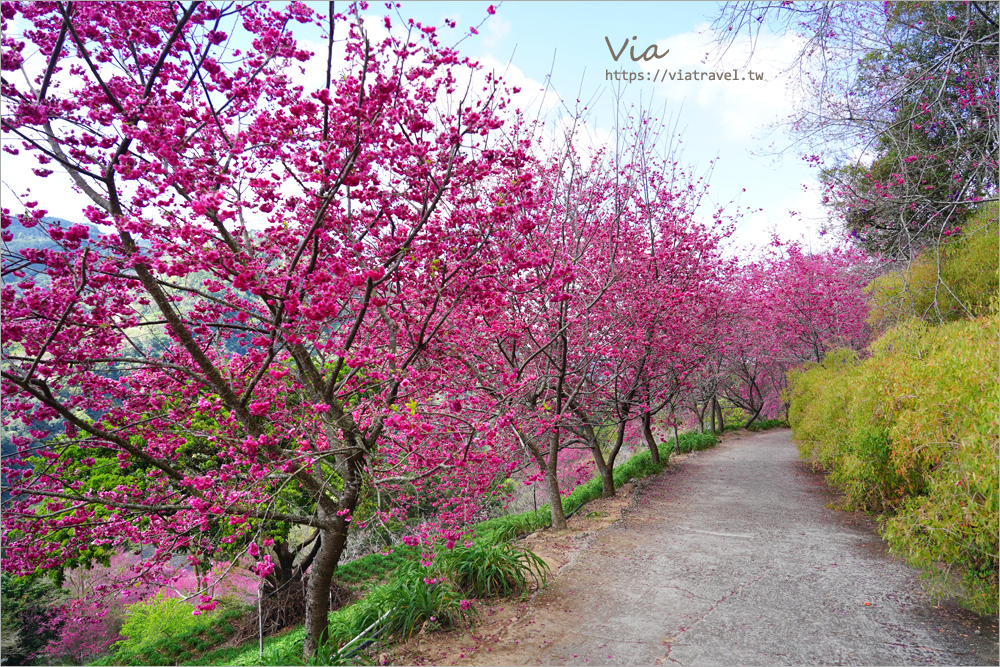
[2,2,530,655]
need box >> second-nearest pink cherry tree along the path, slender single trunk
[456,131,622,530]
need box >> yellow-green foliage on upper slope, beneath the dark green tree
[866,203,1000,330]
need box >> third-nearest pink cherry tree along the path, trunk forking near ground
[578,138,727,488]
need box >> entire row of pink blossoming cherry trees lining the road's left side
[0,2,863,655]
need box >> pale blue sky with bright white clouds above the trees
[2,1,826,256]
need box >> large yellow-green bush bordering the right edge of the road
[789,312,1000,613]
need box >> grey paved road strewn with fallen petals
[472,430,1000,665]
